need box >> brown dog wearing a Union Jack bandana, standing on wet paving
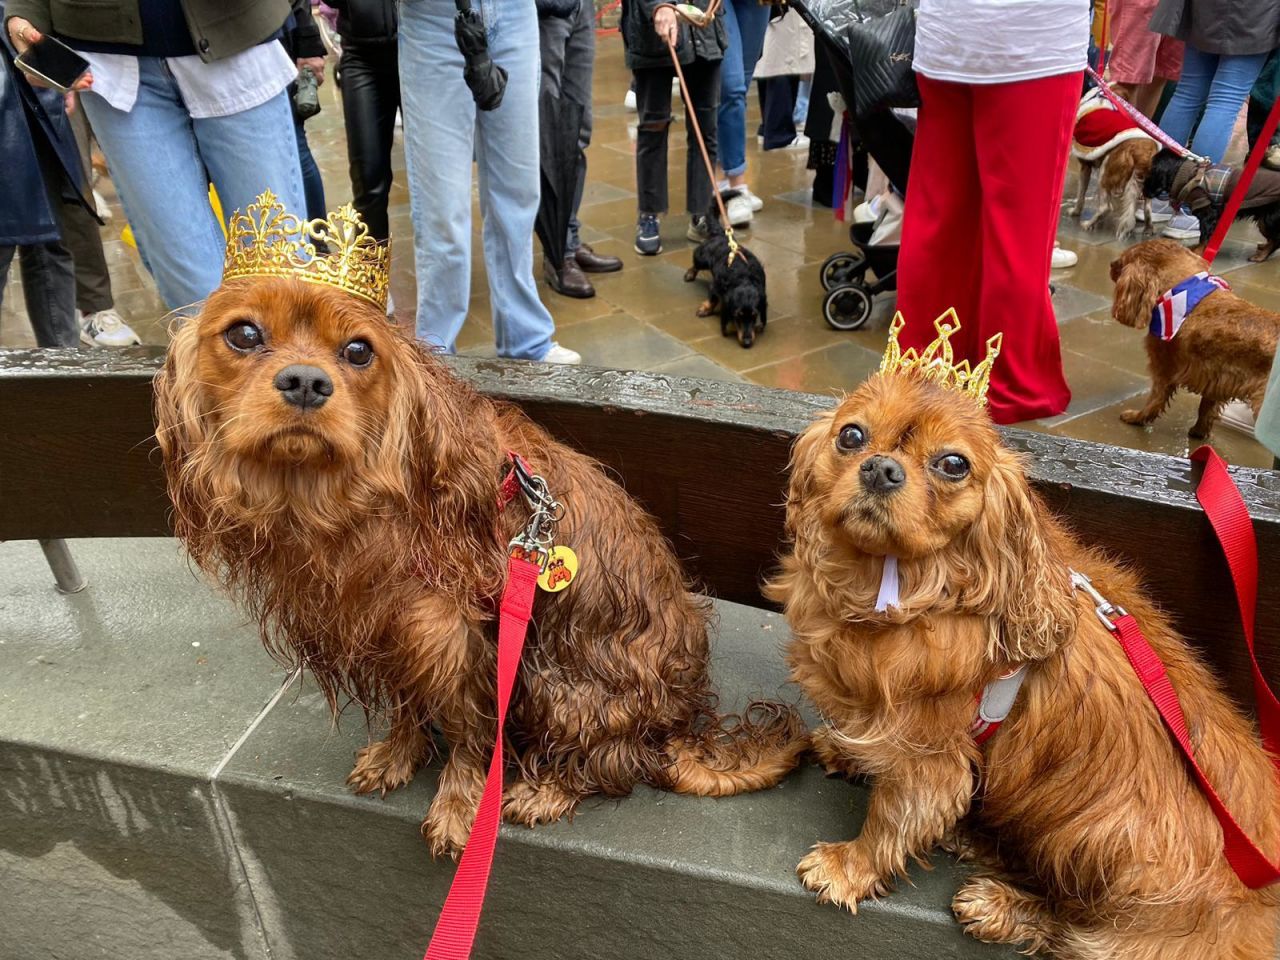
[1111,239,1280,438]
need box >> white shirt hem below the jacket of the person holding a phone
[79,40,298,119]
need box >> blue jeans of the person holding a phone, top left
[81,56,306,310]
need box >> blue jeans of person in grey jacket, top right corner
[1160,44,1267,164]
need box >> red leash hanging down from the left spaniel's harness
[422,453,559,960]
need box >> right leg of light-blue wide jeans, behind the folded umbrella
[471,0,556,360]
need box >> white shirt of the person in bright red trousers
[913,0,1089,83]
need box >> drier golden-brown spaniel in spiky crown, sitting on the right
[771,375,1280,960]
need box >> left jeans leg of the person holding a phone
[81,58,224,310]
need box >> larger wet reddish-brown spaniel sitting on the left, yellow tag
[156,279,806,854]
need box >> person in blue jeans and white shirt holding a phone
[4,0,306,310]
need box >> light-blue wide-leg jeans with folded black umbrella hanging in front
[399,0,556,360]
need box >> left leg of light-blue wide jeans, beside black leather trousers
[399,0,476,353]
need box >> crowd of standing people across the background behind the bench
[0,0,1280,432]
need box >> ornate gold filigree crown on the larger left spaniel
[223,189,392,311]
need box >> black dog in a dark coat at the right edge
[1142,150,1280,264]
